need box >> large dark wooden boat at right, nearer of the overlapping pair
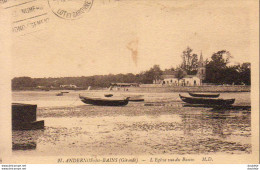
[179,94,235,106]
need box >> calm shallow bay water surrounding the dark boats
[13,91,251,156]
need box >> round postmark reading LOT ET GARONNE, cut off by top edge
[48,0,93,20]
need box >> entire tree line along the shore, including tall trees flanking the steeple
[12,47,251,90]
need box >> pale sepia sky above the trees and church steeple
[12,0,252,77]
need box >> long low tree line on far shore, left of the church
[12,69,162,90]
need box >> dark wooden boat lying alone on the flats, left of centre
[79,95,128,106]
